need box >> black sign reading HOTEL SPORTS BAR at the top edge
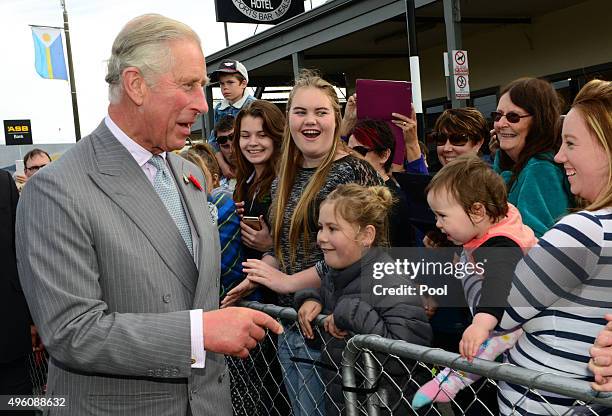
[215,0,304,24]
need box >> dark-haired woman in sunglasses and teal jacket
[491,78,573,238]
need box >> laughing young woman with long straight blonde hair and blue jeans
[224,71,383,416]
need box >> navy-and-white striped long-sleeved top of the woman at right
[499,208,612,415]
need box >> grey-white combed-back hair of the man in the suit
[105,14,202,103]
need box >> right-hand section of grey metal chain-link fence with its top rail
[342,335,612,415]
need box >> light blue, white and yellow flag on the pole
[32,27,68,80]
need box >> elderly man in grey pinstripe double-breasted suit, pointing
[17,15,282,416]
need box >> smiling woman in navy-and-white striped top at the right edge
[499,80,612,415]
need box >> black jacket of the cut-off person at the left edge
[0,170,32,363]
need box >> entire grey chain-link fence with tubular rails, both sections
[30,302,612,416]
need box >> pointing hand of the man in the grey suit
[203,307,283,358]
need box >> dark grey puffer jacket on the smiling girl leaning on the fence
[295,248,432,416]
